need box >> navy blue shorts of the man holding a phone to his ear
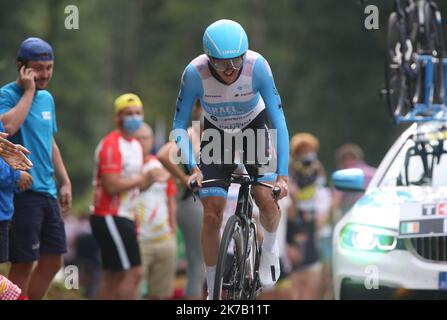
[9,191,67,263]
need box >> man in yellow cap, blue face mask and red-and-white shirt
[90,93,164,299]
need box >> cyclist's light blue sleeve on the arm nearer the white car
[253,57,289,176]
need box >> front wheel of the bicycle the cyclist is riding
[213,215,244,300]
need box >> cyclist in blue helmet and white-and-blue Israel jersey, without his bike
[173,19,289,298]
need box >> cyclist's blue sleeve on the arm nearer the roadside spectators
[173,64,203,170]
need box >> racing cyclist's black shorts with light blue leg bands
[199,110,276,198]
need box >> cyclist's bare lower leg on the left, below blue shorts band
[201,197,227,266]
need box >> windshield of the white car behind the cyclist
[380,131,447,187]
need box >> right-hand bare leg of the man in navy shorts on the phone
[28,254,62,300]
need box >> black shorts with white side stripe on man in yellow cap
[90,215,141,271]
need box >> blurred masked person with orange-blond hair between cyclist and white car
[287,133,331,299]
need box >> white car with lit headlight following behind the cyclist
[332,121,447,299]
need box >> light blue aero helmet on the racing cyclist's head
[203,19,248,59]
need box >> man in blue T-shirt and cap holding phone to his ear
[0,38,71,299]
